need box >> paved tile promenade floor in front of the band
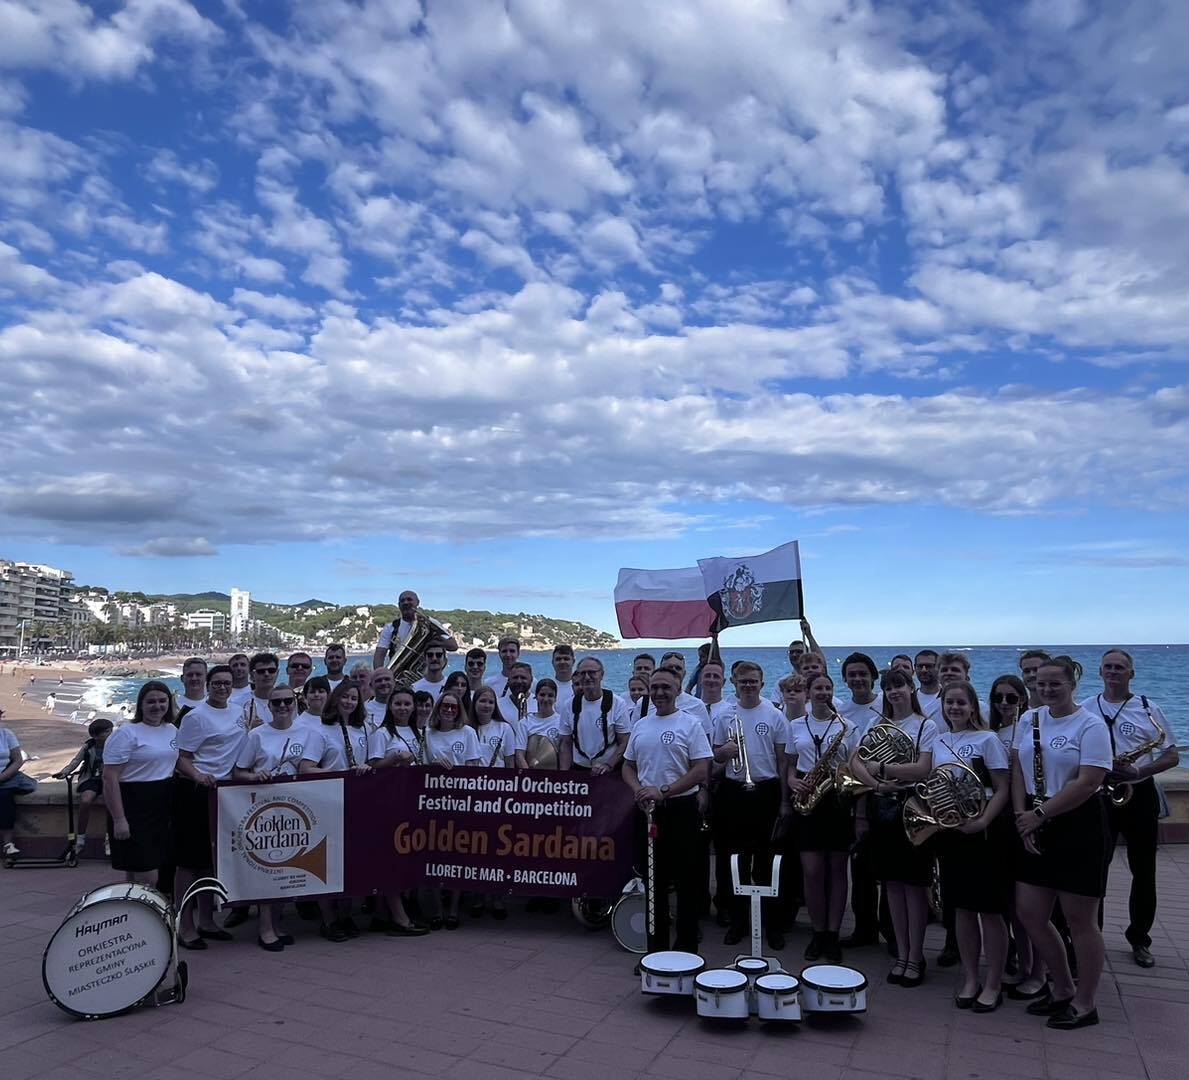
[0,846,1189,1080]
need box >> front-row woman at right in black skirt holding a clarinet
[1012,657,1113,1030]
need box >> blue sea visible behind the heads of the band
[74,645,1189,747]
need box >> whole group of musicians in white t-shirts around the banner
[39,592,1177,1029]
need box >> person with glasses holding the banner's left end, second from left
[174,664,247,949]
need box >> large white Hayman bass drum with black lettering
[42,883,174,1019]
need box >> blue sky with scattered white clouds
[0,0,1189,643]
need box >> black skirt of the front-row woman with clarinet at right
[1015,795,1107,898]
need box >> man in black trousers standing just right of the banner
[623,658,712,953]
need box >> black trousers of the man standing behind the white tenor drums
[636,795,705,953]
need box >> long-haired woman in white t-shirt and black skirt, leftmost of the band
[103,679,177,886]
